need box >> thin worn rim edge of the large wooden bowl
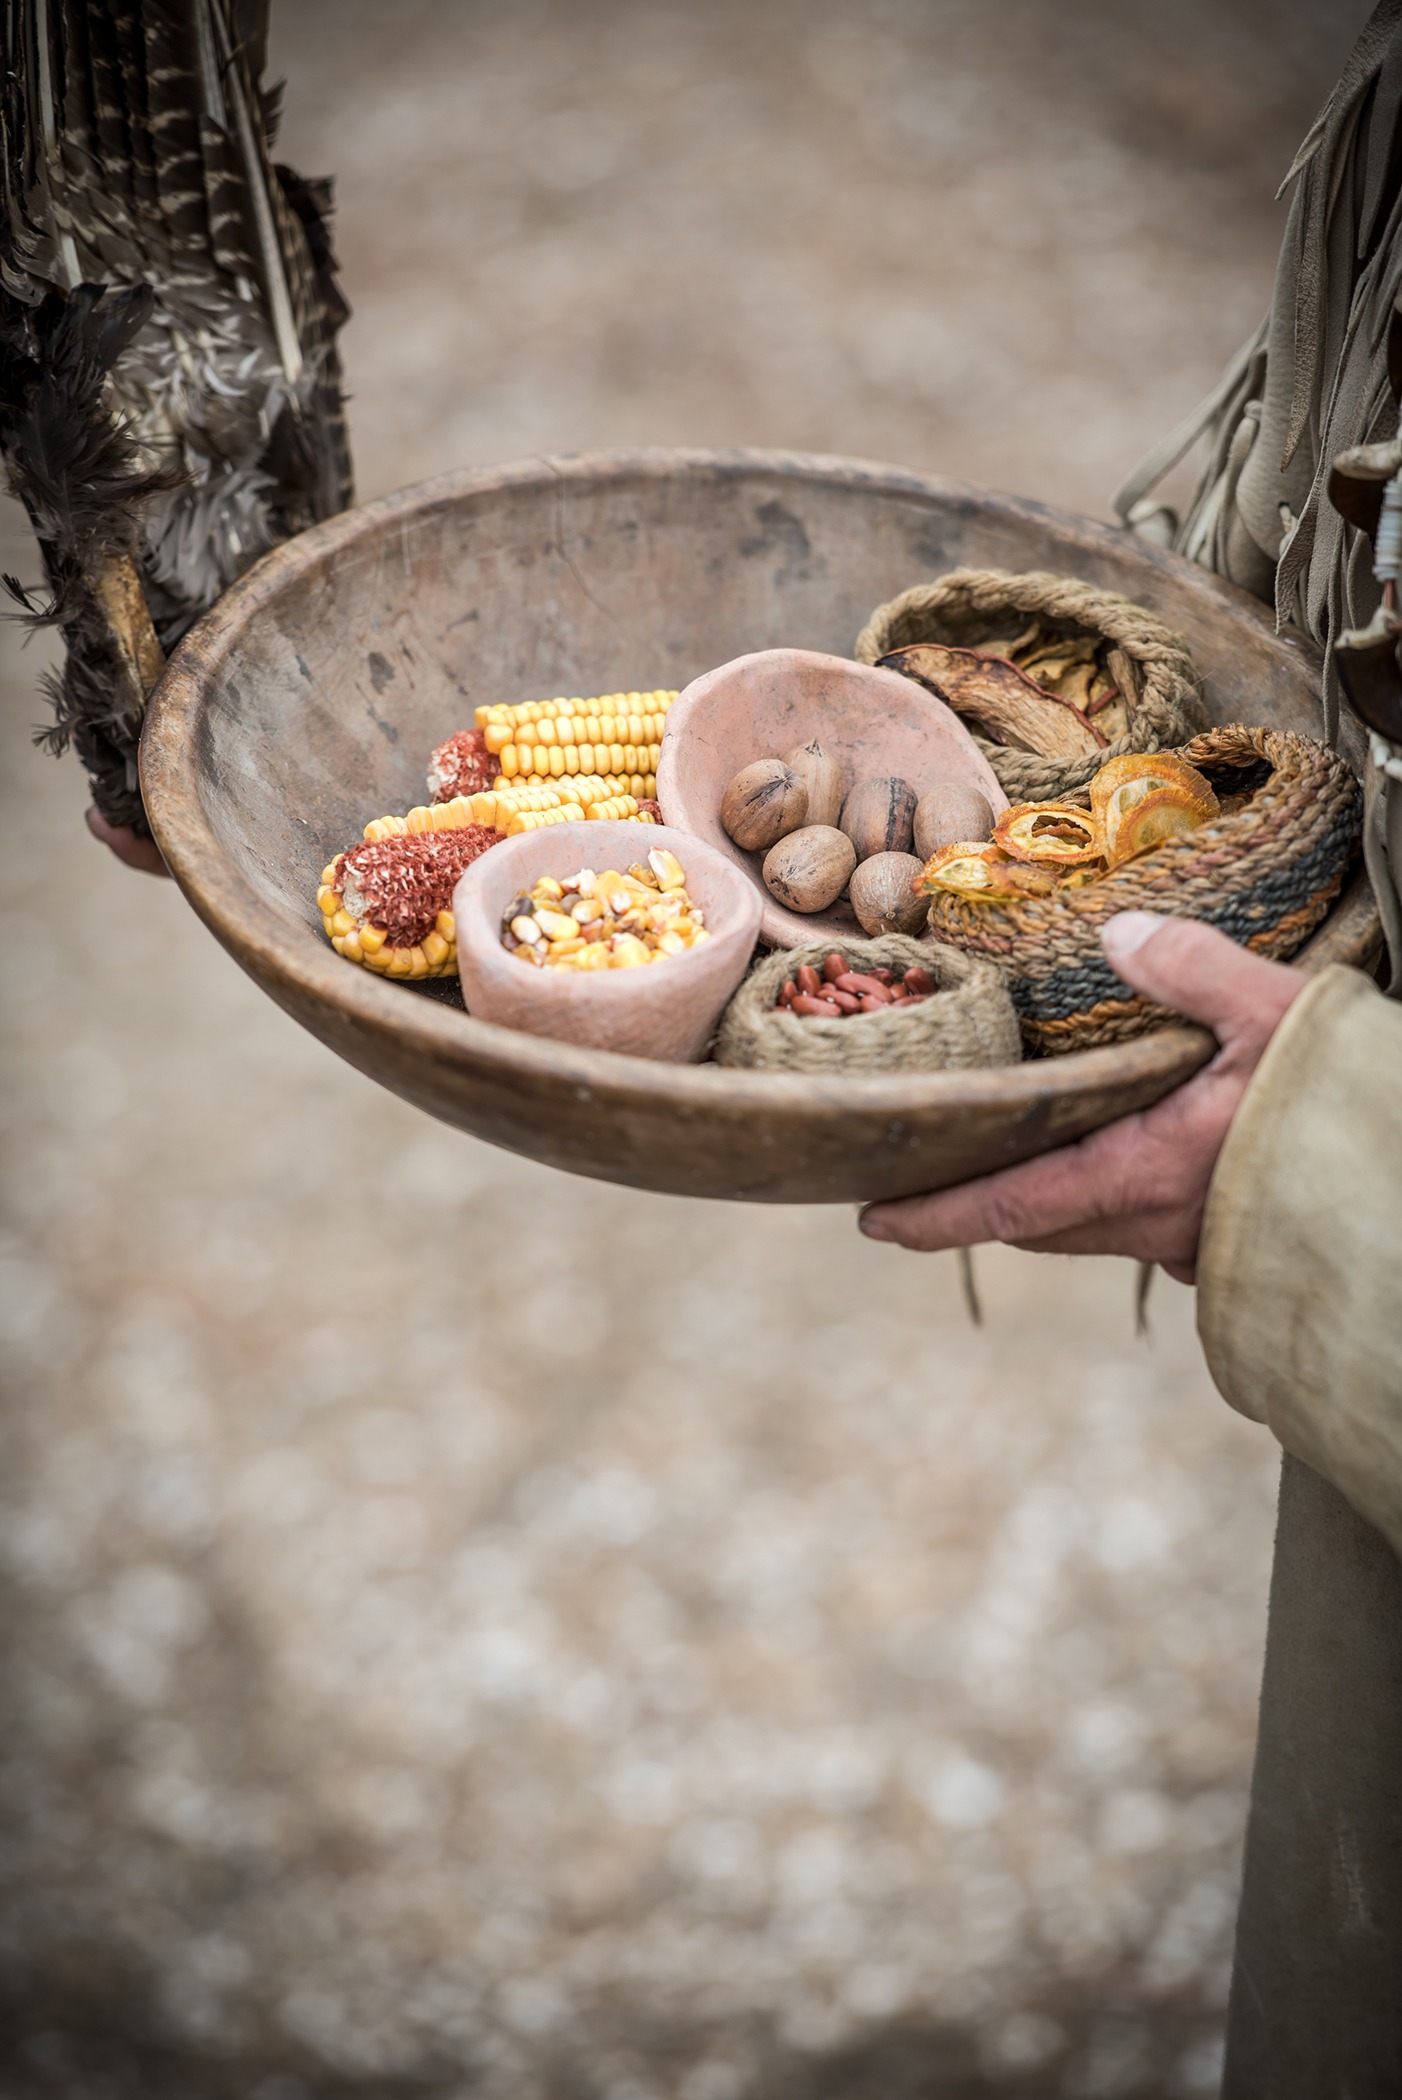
[141,447,1360,1117]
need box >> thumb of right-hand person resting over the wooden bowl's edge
[1100,911,1305,1046]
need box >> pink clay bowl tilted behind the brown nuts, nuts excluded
[657,649,1007,947]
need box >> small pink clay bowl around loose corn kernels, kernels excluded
[453,823,760,1065]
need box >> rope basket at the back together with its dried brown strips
[852,569,1207,802]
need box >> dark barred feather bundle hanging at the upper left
[0,0,351,827]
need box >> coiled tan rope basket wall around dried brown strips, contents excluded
[852,569,1207,802]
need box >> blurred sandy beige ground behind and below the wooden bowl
[0,0,1364,2100]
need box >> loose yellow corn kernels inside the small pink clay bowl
[502,846,709,970]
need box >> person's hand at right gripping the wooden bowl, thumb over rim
[858,911,1308,1283]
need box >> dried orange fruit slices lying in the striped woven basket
[919,752,1217,901]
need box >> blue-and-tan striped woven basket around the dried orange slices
[930,725,1362,1056]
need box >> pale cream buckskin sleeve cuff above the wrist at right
[1198,968,1402,1554]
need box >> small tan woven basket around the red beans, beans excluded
[711,932,1022,1075]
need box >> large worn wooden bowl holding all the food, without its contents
[141,452,1377,1203]
